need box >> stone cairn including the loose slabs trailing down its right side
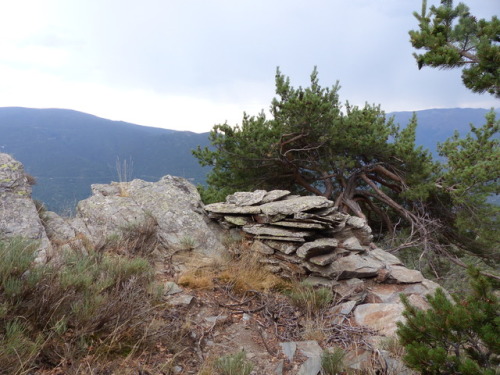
[205,190,439,335]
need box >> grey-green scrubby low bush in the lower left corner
[0,239,158,374]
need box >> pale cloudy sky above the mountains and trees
[0,0,500,132]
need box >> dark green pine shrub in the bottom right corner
[397,269,500,375]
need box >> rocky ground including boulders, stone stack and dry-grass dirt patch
[0,154,426,375]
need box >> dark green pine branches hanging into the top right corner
[410,0,500,98]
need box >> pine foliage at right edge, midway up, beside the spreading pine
[436,111,500,262]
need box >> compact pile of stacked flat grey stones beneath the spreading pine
[205,190,394,280]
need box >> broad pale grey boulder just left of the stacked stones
[77,176,224,255]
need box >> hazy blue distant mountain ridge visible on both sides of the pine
[0,107,498,213]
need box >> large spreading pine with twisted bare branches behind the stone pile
[194,69,436,235]
